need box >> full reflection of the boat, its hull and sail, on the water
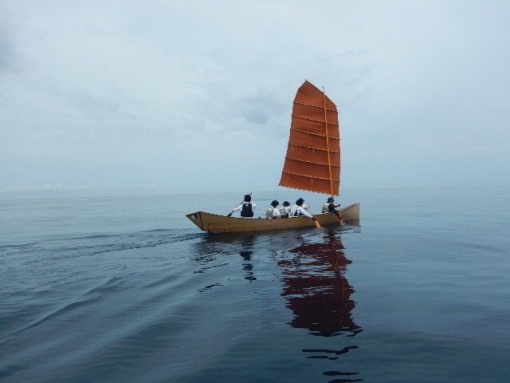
[193,228,361,337]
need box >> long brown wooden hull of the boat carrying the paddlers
[186,203,360,233]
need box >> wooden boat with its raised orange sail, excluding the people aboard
[186,81,360,233]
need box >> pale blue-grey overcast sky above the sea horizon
[0,0,510,196]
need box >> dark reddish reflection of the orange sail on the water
[278,233,361,336]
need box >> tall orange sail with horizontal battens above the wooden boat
[279,81,340,196]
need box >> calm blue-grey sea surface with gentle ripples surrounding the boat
[0,188,510,383]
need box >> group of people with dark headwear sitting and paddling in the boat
[229,194,342,222]
